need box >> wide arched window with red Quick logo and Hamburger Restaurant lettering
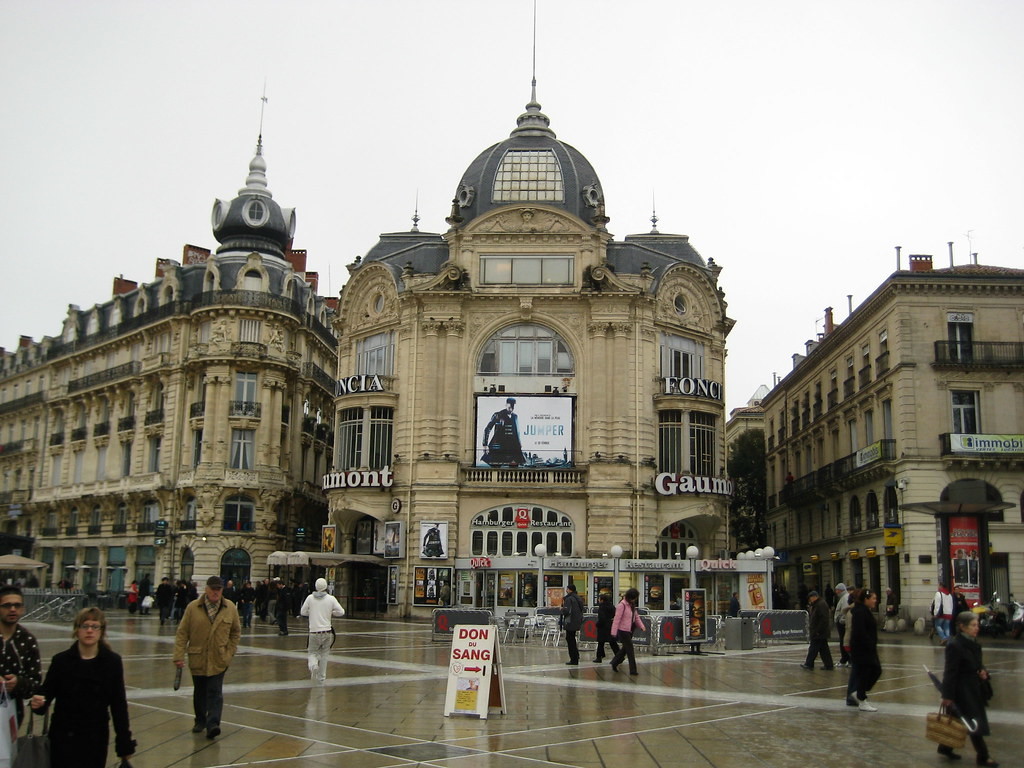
[470,505,575,557]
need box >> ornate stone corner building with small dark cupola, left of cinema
[9,141,338,593]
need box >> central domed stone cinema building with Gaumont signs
[324,88,763,616]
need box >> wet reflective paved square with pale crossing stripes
[26,611,1024,768]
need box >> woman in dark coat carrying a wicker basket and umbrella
[939,611,998,768]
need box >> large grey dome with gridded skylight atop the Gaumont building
[447,80,607,227]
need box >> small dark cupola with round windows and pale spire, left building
[211,136,295,259]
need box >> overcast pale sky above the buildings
[0,0,1024,410]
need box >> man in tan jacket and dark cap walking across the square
[174,577,242,738]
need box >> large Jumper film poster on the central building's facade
[474,393,575,469]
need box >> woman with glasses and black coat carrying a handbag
[32,608,135,768]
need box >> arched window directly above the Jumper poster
[477,324,575,376]
